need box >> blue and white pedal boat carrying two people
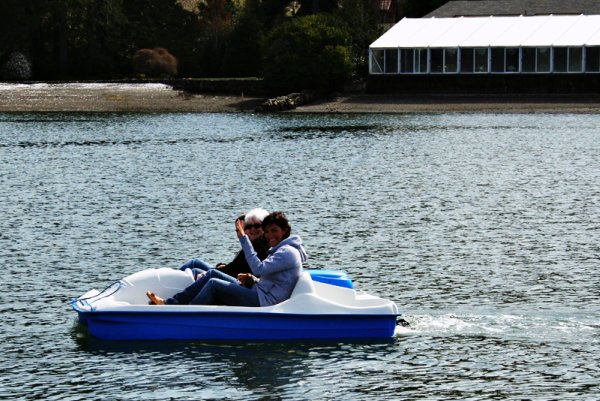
[71,268,400,340]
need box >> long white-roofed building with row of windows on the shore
[369,14,600,76]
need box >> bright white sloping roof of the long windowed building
[369,15,600,48]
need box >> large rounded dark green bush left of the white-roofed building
[264,14,352,93]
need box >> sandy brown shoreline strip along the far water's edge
[0,83,600,114]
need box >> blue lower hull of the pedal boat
[80,312,397,340]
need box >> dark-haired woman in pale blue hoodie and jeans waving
[147,212,307,306]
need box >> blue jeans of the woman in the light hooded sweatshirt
[165,269,260,306]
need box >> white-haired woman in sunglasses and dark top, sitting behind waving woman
[173,208,269,279]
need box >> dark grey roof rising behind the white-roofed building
[425,0,600,18]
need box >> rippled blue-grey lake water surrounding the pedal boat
[0,114,600,400]
